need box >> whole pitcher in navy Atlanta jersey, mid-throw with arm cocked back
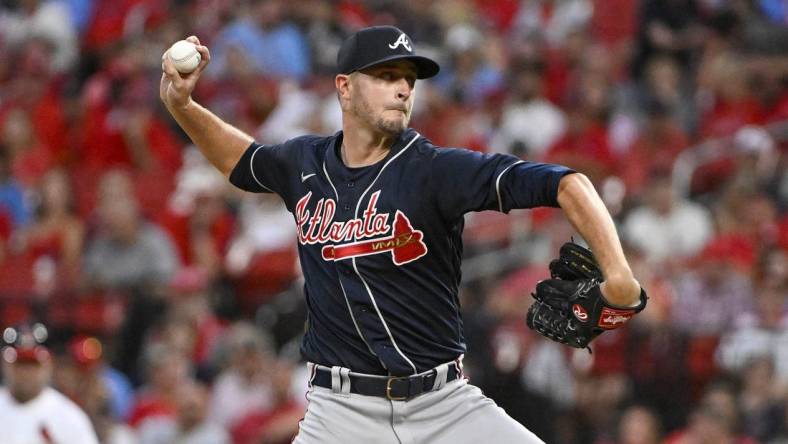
[160,26,646,444]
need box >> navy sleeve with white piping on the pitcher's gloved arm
[433,148,574,218]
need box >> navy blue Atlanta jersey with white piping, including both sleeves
[230,129,571,375]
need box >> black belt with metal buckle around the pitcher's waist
[312,363,462,401]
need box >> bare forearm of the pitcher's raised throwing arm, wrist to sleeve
[167,100,254,177]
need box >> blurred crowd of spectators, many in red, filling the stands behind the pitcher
[0,0,788,444]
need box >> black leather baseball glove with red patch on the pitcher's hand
[526,242,648,351]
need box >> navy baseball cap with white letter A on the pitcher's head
[337,26,440,79]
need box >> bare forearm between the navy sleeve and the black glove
[558,174,640,306]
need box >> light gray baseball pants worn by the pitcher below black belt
[293,364,544,444]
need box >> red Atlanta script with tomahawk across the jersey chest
[295,191,427,265]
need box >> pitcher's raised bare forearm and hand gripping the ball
[159,36,254,177]
